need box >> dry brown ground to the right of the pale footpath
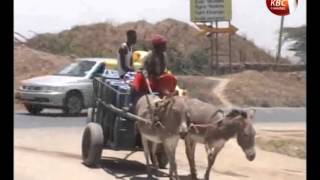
[225,71,306,107]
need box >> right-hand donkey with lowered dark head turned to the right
[185,99,256,180]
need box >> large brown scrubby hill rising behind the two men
[27,19,288,74]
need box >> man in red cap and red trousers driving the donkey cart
[132,34,177,104]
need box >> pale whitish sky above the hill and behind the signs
[14,0,306,59]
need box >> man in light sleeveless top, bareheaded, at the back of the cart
[118,30,137,79]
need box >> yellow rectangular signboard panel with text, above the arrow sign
[190,0,232,22]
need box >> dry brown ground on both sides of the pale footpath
[177,70,306,107]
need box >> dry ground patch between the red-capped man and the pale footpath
[177,76,221,105]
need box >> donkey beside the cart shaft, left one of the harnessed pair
[135,95,190,180]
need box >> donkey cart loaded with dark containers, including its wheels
[82,77,168,168]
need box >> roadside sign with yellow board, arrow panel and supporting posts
[190,0,238,73]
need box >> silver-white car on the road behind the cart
[15,58,117,114]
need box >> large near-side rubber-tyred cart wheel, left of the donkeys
[82,123,104,167]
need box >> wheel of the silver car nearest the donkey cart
[63,93,83,115]
